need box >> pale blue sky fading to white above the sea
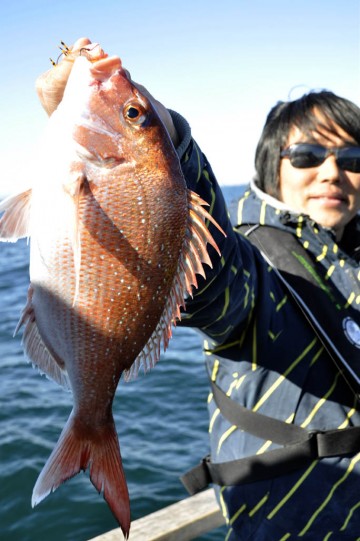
[0,0,360,193]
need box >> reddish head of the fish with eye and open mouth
[67,52,175,169]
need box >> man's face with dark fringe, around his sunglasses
[278,118,360,240]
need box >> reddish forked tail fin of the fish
[31,414,130,539]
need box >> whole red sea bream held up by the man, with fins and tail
[0,42,224,537]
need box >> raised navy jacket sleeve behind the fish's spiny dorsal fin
[171,112,258,344]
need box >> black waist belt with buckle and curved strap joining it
[181,383,360,494]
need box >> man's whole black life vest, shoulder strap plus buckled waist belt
[181,225,360,494]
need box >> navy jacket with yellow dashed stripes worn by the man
[172,109,360,541]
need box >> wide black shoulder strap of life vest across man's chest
[237,224,360,392]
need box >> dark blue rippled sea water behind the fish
[0,187,242,541]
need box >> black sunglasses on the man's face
[280,143,360,173]
